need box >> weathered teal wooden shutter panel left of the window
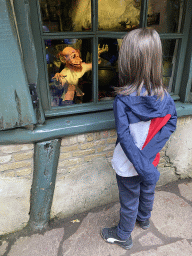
[0,0,36,130]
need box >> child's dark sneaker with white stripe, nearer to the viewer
[101,227,133,250]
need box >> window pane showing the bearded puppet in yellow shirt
[45,39,92,107]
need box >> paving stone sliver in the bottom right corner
[130,240,192,256]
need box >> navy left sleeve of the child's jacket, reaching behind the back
[114,97,177,184]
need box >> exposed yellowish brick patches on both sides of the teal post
[0,130,116,179]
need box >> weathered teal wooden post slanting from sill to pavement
[29,139,61,230]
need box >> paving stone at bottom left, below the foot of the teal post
[8,228,64,256]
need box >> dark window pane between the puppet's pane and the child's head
[98,38,122,101]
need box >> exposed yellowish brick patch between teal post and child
[57,130,116,179]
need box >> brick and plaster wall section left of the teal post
[0,144,33,234]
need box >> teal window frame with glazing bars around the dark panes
[29,0,191,118]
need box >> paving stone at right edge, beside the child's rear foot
[151,191,192,239]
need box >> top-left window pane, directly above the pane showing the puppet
[39,0,91,32]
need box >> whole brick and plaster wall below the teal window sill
[0,116,192,234]
